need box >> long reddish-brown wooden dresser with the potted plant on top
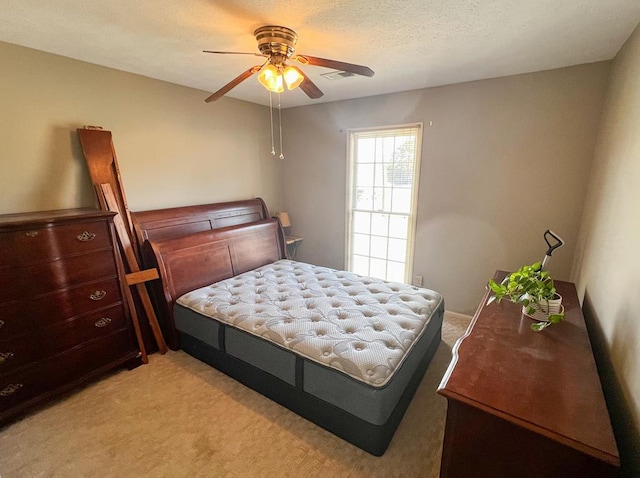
[438,271,620,478]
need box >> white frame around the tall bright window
[344,122,424,284]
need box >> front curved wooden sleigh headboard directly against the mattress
[143,219,286,350]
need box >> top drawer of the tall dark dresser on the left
[0,221,111,267]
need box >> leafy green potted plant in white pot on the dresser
[487,262,564,332]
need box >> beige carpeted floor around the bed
[0,314,469,478]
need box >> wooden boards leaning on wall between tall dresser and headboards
[77,126,167,356]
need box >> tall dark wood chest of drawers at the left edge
[0,209,139,425]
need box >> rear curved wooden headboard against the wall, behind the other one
[131,198,269,267]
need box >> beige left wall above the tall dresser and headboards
[0,43,281,213]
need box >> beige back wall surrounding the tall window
[283,62,610,314]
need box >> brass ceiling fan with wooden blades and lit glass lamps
[204,25,374,103]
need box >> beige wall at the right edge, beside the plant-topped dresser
[574,22,640,466]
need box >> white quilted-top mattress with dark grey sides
[174,260,444,425]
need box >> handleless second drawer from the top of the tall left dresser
[0,249,117,303]
